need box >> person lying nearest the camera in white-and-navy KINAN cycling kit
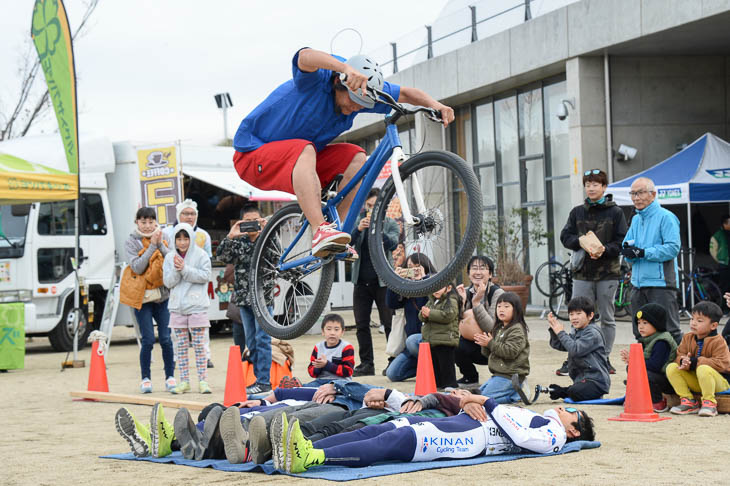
[271,394,595,473]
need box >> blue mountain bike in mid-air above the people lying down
[249,82,482,339]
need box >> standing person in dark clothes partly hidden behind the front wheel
[351,188,400,376]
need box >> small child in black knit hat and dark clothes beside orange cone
[621,303,677,413]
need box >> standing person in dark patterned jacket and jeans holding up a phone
[217,204,273,395]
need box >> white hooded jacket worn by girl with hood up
[162,223,210,315]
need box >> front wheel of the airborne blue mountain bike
[368,151,482,297]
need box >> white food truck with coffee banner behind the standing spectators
[0,135,294,351]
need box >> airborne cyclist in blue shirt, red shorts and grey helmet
[233,48,454,258]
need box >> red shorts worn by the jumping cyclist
[233,138,365,194]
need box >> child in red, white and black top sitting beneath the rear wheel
[305,314,355,386]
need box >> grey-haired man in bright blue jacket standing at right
[621,177,682,343]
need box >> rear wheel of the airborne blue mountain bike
[249,204,335,339]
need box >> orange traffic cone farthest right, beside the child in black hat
[608,343,671,422]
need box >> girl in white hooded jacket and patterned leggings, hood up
[162,223,211,394]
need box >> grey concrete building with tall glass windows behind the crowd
[332,0,730,303]
